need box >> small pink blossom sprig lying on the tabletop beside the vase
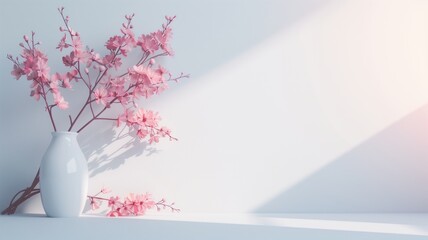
[88,188,180,217]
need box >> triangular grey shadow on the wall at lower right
[254,105,428,213]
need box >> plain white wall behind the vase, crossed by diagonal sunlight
[0,0,428,213]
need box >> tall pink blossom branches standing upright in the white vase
[8,8,188,143]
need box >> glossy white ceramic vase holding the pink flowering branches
[40,132,88,217]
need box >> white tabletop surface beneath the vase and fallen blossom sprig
[0,213,428,240]
